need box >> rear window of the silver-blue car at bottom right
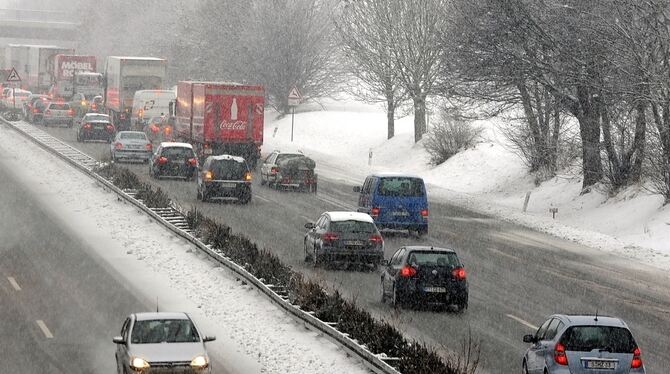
[561,326,636,353]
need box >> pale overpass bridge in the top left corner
[0,8,81,47]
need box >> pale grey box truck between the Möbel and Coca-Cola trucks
[104,56,167,130]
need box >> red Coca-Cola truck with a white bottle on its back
[171,81,265,166]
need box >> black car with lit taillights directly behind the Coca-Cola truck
[198,155,251,204]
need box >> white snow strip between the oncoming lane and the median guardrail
[0,125,368,374]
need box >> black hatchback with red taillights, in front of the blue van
[381,246,468,311]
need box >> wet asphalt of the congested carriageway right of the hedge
[34,122,670,374]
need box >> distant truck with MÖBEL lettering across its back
[49,55,104,100]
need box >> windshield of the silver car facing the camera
[130,319,200,344]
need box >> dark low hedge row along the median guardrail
[99,164,472,374]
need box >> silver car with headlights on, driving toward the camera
[113,312,216,374]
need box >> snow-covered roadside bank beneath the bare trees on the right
[265,100,670,269]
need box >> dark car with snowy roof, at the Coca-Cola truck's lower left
[149,142,198,180]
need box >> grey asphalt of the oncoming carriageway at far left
[0,139,232,374]
